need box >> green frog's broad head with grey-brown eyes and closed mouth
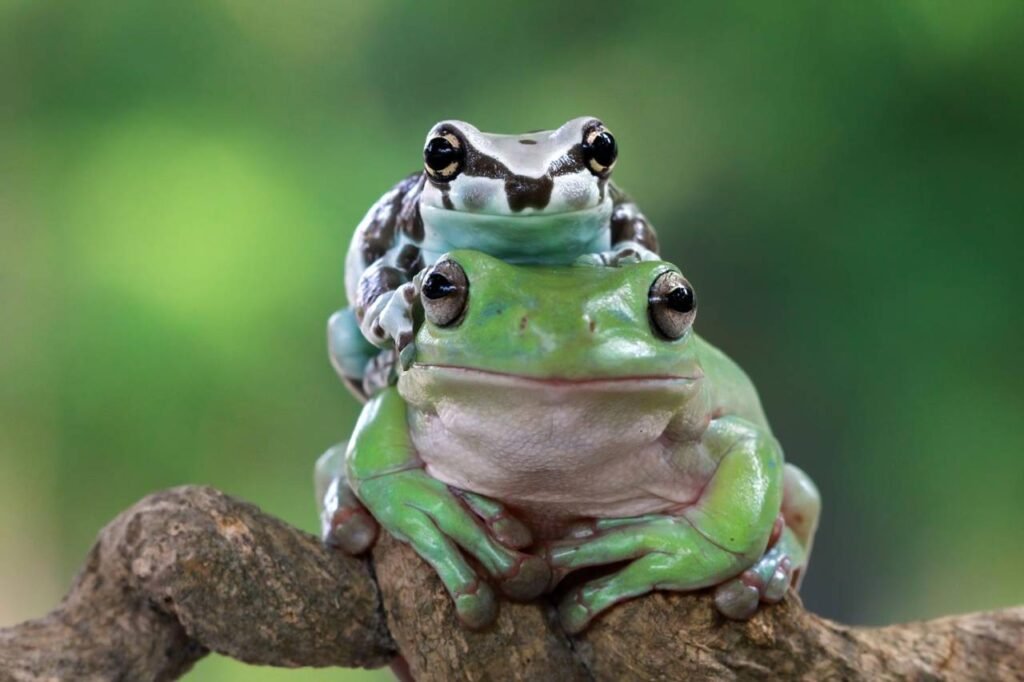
[399,251,702,406]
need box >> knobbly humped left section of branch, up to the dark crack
[0,487,394,681]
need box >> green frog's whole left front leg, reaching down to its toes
[346,386,551,627]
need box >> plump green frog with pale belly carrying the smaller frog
[316,250,820,634]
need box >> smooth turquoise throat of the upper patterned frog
[420,202,611,265]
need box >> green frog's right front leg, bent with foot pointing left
[546,417,782,633]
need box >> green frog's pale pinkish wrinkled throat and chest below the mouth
[402,364,714,524]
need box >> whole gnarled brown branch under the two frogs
[0,487,1024,682]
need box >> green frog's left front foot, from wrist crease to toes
[359,469,551,628]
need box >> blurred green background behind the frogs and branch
[0,0,1024,680]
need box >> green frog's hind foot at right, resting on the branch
[715,464,821,621]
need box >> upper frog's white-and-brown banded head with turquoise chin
[420,117,617,262]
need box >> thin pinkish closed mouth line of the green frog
[408,363,702,390]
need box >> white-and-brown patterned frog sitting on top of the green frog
[328,116,658,399]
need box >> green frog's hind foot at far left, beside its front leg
[313,442,379,554]
